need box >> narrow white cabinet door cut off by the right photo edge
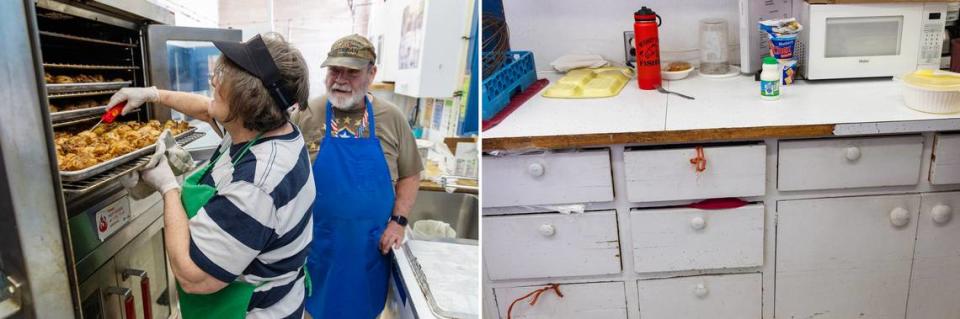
[907,192,960,319]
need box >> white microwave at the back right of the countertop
[799,2,947,80]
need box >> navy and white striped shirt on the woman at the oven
[190,127,316,318]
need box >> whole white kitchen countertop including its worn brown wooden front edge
[483,72,960,151]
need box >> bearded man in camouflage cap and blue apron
[291,35,423,319]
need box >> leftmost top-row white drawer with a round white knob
[482,149,613,207]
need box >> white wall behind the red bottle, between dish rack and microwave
[503,0,740,70]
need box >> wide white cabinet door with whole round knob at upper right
[775,195,920,319]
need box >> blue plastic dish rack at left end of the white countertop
[481,51,537,121]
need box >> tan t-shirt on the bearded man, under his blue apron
[290,94,423,183]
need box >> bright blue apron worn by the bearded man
[306,98,394,319]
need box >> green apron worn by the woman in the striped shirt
[177,133,263,319]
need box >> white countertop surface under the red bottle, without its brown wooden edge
[483,72,960,139]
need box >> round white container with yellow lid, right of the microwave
[901,70,960,114]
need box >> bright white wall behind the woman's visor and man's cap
[219,0,354,97]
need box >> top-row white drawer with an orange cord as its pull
[623,144,767,202]
